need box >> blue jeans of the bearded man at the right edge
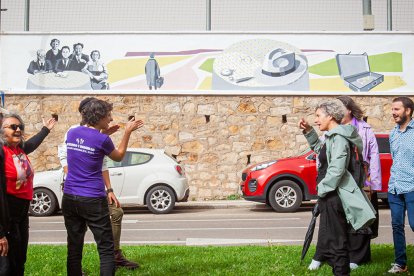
[388,192,414,266]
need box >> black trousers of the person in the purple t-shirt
[62,194,115,276]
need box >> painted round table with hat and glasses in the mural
[212,39,309,91]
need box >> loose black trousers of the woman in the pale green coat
[313,191,350,276]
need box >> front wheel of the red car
[269,180,302,213]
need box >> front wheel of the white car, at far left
[29,188,57,217]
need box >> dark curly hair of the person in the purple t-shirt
[81,99,113,126]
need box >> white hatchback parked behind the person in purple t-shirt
[29,148,190,216]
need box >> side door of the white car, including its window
[120,151,155,204]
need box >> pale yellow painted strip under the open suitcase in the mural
[310,76,406,91]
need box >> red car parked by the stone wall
[240,134,392,212]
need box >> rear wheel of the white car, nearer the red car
[145,185,175,214]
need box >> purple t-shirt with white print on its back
[63,126,115,197]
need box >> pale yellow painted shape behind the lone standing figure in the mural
[107,56,191,83]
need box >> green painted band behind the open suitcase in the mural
[309,52,403,76]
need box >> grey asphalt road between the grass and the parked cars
[30,204,414,245]
